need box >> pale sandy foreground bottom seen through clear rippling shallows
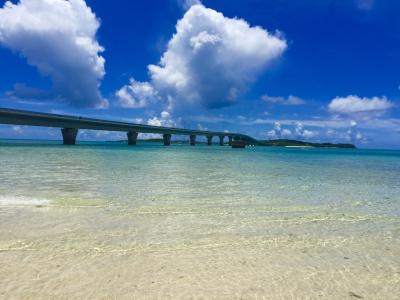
[0,205,400,299]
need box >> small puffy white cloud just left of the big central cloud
[115,79,157,108]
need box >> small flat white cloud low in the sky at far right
[328,95,393,117]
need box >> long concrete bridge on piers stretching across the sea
[0,108,257,146]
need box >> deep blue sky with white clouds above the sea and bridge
[0,0,400,149]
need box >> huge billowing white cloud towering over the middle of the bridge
[119,4,287,111]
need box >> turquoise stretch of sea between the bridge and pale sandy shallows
[0,142,400,216]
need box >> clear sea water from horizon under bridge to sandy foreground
[0,140,400,299]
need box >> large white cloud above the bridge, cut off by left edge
[0,0,108,107]
